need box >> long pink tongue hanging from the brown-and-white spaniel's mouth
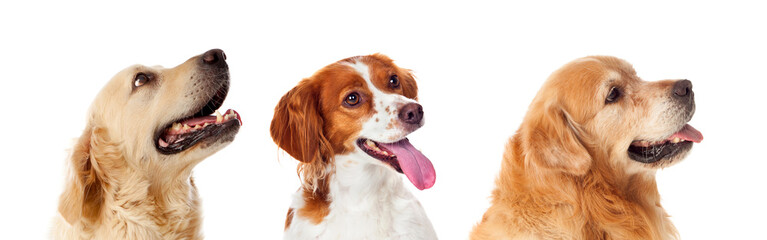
[379,138,437,190]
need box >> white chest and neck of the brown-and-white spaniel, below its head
[286,151,424,239]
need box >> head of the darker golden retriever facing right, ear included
[522,56,703,175]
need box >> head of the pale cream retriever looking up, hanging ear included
[60,49,240,223]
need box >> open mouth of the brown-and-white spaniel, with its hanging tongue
[357,138,437,190]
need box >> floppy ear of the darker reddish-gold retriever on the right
[522,104,591,175]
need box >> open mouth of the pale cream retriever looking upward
[155,85,242,154]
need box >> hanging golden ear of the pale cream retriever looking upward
[59,126,104,224]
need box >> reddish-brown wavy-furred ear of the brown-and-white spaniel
[270,79,333,163]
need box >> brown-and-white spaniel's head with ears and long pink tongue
[271,54,435,189]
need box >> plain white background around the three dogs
[0,1,767,239]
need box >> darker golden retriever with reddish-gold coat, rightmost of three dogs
[470,56,703,240]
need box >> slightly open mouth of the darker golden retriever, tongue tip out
[628,124,703,163]
